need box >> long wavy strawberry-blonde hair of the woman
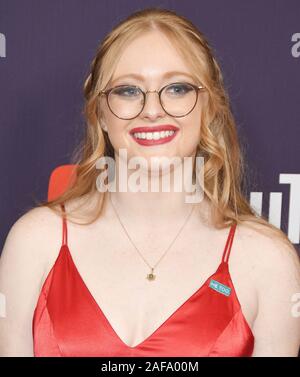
[34,8,293,247]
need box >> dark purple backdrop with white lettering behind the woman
[0,0,300,250]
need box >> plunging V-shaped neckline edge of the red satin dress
[62,244,226,350]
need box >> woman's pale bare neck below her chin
[105,156,208,228]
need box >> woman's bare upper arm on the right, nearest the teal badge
[253,235,300,356]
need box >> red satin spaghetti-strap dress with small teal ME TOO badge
[32,205,254,357]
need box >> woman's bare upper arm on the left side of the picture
[0,208,56,356]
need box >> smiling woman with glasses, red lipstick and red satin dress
[0,9,300,356]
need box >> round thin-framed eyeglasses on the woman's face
[99,82,205,120]
